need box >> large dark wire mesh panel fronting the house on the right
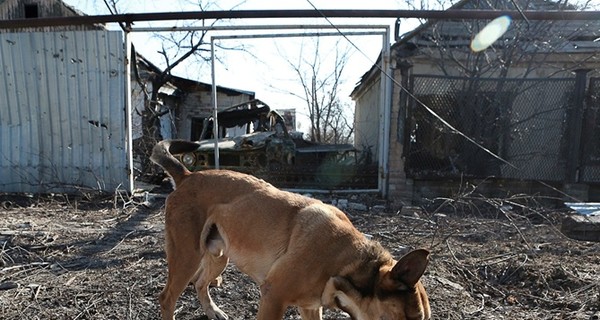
[406,75,575,181]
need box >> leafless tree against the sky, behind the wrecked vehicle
[287,38,354,143]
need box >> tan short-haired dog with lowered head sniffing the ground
[151,140,430,320]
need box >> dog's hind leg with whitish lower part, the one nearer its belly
[195,252,229,320]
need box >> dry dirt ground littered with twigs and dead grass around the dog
[0,189,600,320]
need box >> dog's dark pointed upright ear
[382,249,429,291]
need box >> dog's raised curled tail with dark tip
[150,140,198,186]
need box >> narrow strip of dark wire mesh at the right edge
[580,78,600,183]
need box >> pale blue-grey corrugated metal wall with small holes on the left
[0,31,129,193]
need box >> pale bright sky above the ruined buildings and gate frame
[64,0,424,132]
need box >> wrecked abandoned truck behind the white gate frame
[177,99,377,189]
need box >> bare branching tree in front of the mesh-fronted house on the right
[399,0,597,176]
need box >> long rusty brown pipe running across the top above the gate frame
[0,9,600,29]
